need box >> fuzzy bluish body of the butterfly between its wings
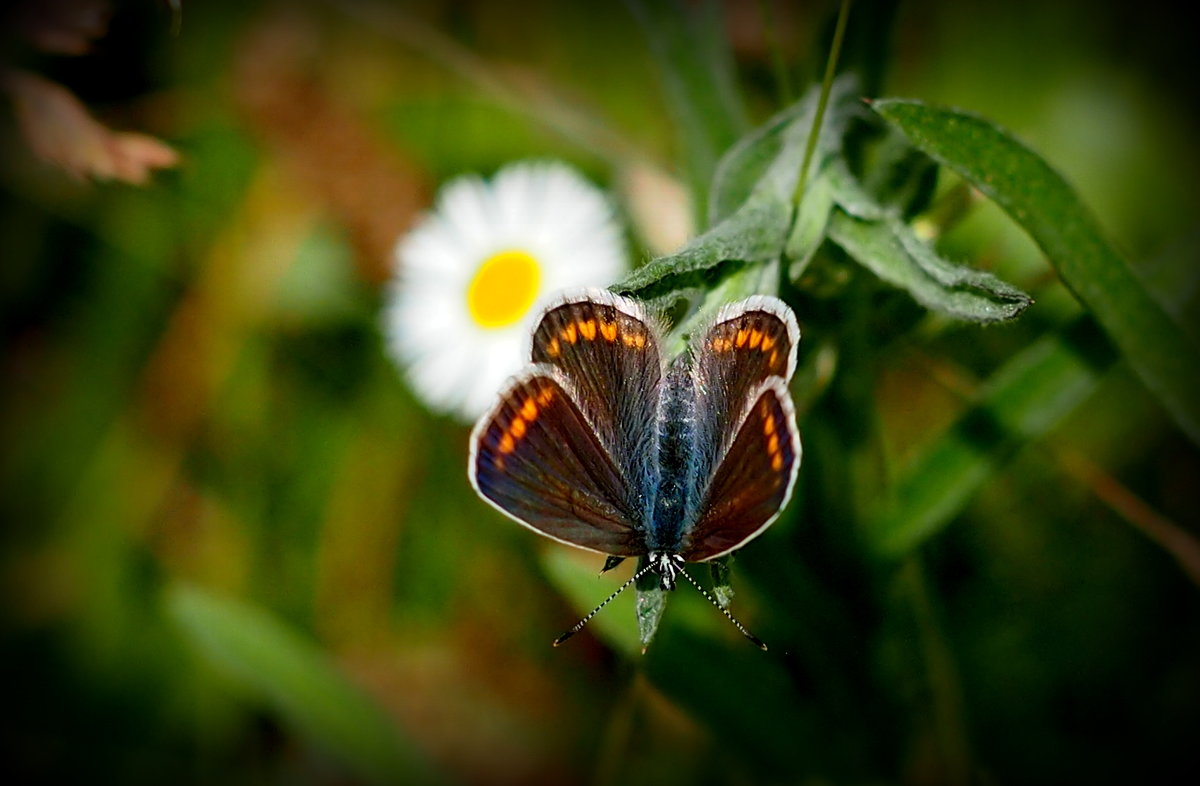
[646,358,696,554]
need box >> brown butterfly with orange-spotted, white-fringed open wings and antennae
[468,289,800,649]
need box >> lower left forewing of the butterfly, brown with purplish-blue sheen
[468,364,646,556]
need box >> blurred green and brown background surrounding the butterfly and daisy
[0,0,1200,784]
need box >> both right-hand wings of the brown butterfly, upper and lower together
[684,296,800,560]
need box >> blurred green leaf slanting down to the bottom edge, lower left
[167,584,440,784]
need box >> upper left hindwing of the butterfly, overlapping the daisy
[530,289,662,516]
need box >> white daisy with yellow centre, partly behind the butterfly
[384,162,626,422]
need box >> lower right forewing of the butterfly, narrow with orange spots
[682,378,800,562]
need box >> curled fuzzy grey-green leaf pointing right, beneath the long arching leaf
[828,210,1032,323]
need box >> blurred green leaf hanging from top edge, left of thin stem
[629,0,749,216]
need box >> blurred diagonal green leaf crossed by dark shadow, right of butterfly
[866,318,1115,558]
